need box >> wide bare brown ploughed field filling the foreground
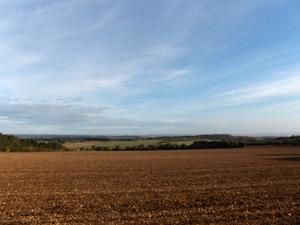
[0,147,300,224]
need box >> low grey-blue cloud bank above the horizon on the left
[0,100,204,135]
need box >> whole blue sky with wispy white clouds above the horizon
[0,0,300,135]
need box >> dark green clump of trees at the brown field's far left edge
[0,133,63,152]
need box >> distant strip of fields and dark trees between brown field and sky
[4,134,300,152]
